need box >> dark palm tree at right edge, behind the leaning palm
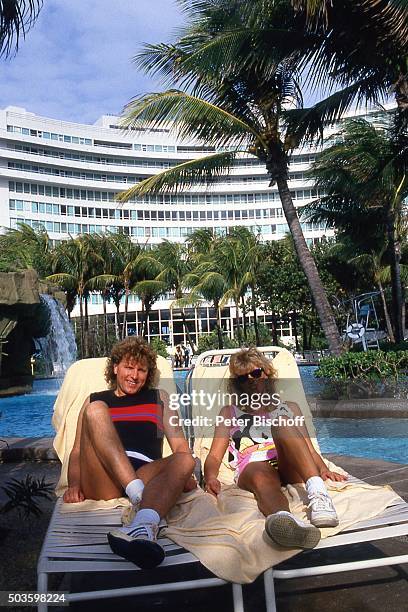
[304,119,408,342]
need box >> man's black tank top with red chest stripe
[89,389,163,459]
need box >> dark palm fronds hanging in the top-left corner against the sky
[0,0,43,57]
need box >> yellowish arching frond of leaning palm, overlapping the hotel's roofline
[121,90,261,147]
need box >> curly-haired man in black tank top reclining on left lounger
[64,336,196,568]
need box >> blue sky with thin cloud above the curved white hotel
[0,0,183,123]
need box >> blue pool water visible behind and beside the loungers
[0,366,408,463]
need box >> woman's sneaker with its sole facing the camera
[264,511,321,549]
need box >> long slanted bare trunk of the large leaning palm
[276,177,343,355]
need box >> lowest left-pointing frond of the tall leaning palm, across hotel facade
[116,151,237,202]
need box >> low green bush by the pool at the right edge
[315,351,408,398]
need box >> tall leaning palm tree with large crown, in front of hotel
[118,3,342,354]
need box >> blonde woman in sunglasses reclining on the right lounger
[204,348,347,548]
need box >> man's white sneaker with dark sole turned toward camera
[108,523,165,569]
